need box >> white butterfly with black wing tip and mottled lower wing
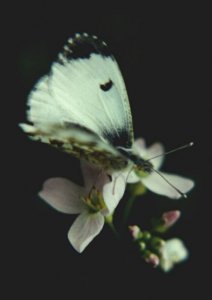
[20,33,152,172]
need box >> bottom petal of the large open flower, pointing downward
[68,211,104,253]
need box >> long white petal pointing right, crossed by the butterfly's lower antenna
[142,171,194,199]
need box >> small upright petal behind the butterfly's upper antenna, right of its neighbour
[145,143,165,170]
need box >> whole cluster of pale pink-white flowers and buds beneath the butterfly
[39,139,194,271]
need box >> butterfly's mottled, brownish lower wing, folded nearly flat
[21,123,129,170]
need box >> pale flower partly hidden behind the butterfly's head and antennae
[128,139,194,199]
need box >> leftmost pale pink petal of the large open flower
[39,178,85,214]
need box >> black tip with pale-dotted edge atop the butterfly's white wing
[58,32,113,64]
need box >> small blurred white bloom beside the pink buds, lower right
[160,238,188,272]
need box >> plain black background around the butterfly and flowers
[1,4,211,299]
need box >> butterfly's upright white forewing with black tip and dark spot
[51,34,133,147]
